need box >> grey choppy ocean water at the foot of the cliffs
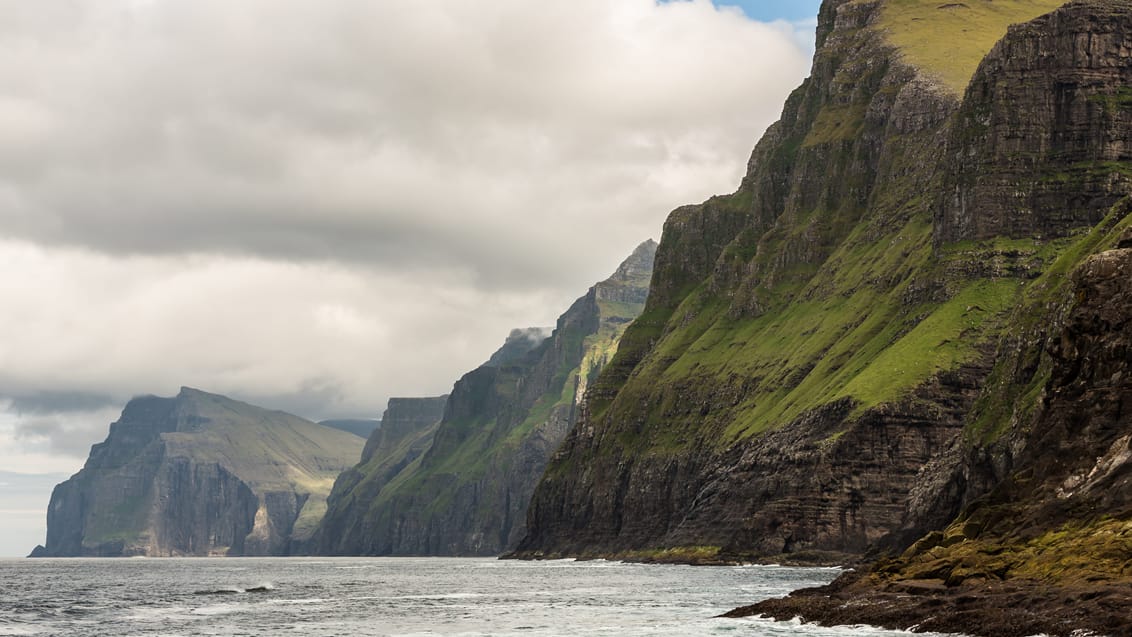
[0,558,955,637]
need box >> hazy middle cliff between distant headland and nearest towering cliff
[319,241,655,556]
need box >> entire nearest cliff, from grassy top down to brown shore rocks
[516,0,1132,635]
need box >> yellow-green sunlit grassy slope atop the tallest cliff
[882,0,1065,94]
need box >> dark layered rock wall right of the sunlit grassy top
[936,3,1132,241]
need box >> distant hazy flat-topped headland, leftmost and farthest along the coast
[34,387,363,557]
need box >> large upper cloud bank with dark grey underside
[0,0,805,281]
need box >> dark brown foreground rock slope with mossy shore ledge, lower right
[735,210,1132,637]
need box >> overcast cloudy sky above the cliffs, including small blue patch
[0,0,818,556]
